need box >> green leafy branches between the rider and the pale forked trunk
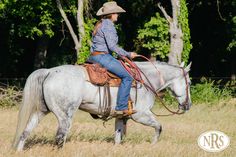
[136,13,170,59]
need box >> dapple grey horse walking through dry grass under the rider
[13,62,191,150]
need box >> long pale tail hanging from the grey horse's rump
[12,69,49,149]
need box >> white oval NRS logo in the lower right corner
[198,131,230,152]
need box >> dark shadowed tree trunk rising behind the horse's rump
[34,36,49,69]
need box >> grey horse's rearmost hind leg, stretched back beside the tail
[16,112,47,151]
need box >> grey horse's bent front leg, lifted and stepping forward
[132,111,162,144]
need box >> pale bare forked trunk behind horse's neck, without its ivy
[158,0,183,65]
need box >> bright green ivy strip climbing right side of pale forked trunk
[178,0,193,63]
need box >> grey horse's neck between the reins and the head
[136,62,180,90]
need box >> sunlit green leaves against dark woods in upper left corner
[0,0,57,39]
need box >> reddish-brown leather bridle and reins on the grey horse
[123,55,189,116]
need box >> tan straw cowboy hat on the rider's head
[96,1,126,16]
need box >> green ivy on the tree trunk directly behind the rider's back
[77,19,97,64]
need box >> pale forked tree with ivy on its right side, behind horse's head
[158,0,192,65]
